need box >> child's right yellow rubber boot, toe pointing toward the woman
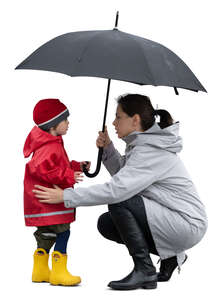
[49,251,81,286]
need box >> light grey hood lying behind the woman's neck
[123,122,183,153]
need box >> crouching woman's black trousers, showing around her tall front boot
[97,196,158,255]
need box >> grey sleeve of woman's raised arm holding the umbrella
[102,142,126,176]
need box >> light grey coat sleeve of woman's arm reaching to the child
[63,148,166,208]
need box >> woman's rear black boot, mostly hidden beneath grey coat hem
[157,255,187,282]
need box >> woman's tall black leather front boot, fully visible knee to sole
[108,204,157,290]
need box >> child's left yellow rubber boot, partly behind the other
[32,248,50,282]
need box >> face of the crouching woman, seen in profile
[113,105,137,138]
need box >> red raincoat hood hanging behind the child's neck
[23,126,62,157]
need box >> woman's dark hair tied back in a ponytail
[117,94,173,131]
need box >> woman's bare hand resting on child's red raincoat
[32,185,64,204]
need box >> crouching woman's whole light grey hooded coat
[64,123,207,265]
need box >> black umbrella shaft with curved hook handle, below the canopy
[83,79,111,178]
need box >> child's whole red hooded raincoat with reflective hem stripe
[23,126,81,226]
